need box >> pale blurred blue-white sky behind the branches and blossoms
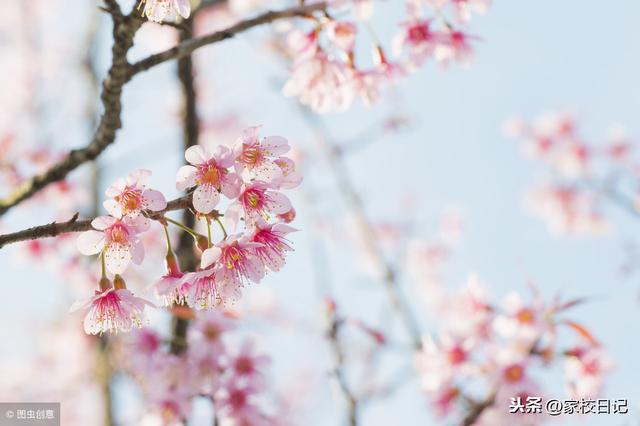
[0,0,640,426]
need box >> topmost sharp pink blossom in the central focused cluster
[233,126,292,182]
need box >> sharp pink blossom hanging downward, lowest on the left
[71,287,153,334]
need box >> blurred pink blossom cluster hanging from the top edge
[283,0,489,113]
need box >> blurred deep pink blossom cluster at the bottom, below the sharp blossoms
[122,310,275,426]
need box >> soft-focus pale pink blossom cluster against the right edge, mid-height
[506,112,640,235]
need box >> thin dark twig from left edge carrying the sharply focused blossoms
[0,195,191,249]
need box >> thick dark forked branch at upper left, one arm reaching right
[0,4,327,220]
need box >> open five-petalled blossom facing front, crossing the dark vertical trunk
[176,145,240,214]
